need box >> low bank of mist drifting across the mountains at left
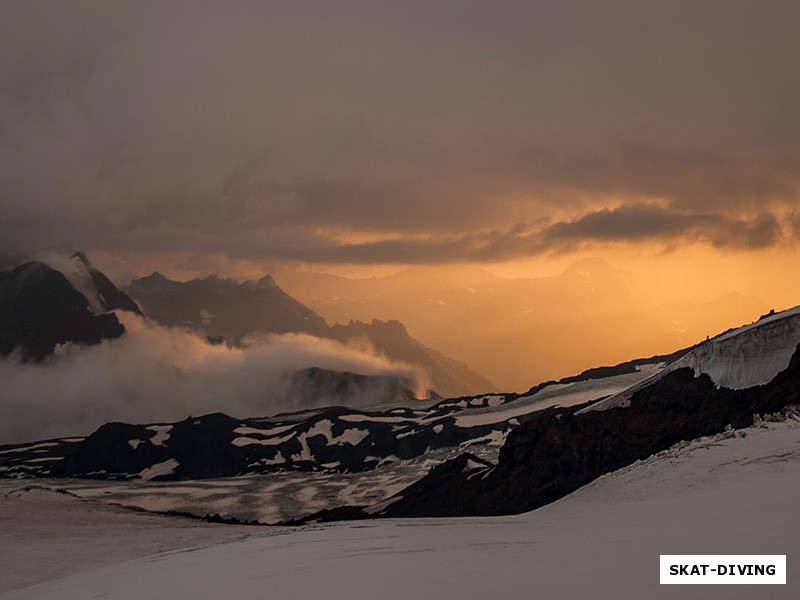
[0,313,425,443]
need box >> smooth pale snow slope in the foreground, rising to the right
[0,414,800,600]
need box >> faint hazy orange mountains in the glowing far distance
[274,259,771,391]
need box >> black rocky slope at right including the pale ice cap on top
[334,307,800,518]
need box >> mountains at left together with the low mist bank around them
[0,253,491,441]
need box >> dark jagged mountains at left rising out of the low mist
[0,252,493,422]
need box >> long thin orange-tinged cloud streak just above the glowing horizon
[189,202,797,264]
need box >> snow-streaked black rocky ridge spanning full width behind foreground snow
[6,307,800,523]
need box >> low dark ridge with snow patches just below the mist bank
[15,399,509,480]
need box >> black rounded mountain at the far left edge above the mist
[0,262,125,360]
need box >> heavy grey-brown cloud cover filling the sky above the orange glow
[0,1,800,262]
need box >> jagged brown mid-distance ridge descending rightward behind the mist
[126,273,495,396]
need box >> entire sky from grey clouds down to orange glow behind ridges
[0,2,800,390]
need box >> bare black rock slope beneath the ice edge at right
[380,350,800,517]
